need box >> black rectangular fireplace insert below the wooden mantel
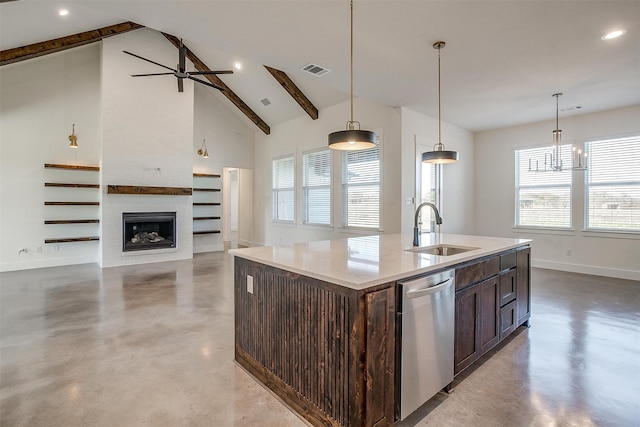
[122,212,176,252]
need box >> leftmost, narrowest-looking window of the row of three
[272,156,295,222]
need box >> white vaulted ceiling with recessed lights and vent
[0,0,640,131]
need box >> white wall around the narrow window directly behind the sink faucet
[401,107,474,234]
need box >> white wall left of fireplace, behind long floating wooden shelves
[0,44,100,271]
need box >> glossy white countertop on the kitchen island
[229,233,531,290]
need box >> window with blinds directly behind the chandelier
[515,145,572,228]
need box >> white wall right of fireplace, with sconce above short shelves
[192,82,254,253]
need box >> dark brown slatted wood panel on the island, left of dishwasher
[235,257,395,426]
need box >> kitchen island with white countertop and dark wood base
[230,234,530,426]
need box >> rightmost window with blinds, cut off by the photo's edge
[585,136,640,232]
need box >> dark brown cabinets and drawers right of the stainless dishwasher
[454,248,531,374]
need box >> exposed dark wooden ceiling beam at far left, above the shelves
[0,22,144,66]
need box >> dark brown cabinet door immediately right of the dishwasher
[454,286,480,374]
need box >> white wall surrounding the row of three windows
[254,98,401,245]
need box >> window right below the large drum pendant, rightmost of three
[342,145,380,228]
